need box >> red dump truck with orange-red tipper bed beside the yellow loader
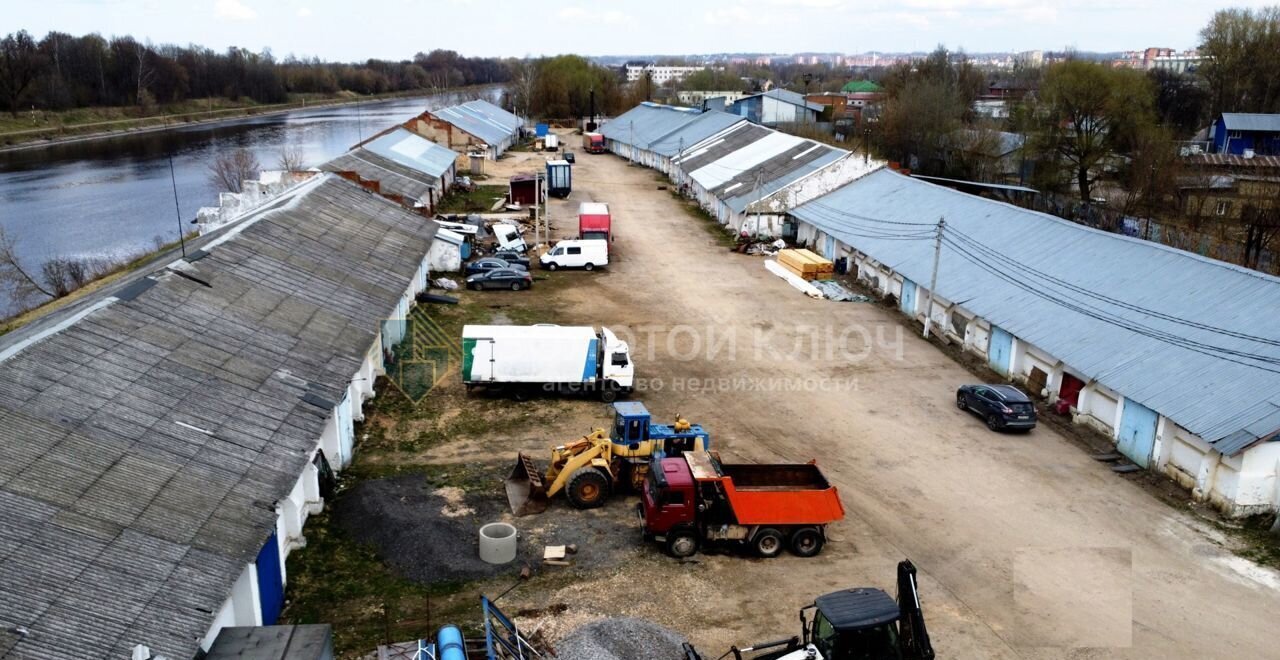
[640,452,845,558]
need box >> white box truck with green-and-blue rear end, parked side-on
[462,325,635,402]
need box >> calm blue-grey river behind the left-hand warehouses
[0,87,502,316]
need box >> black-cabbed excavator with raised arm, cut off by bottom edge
[684,560,933,660]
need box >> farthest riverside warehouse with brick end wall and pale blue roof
[404,100,524,160]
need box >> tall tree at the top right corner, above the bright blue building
[1199,6,1280,116]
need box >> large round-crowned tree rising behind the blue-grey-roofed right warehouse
[1034,60,1155,203]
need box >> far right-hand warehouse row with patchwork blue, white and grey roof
[602,104,883,235]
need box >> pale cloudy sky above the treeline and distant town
[10,0,1268,60]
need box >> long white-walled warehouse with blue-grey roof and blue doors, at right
[791,170,1280,515]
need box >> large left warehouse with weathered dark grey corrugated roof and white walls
[0,174,435,660]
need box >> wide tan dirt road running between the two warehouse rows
[499,144,1280,657]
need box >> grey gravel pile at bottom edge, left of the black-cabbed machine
[556,617,685,660]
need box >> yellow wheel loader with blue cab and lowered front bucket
[503,402,710,515]
